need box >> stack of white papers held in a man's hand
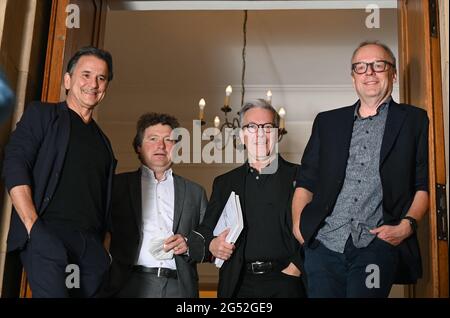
[213,191,244,268]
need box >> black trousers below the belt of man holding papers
[236,271,306,298]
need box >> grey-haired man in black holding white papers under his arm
[198,100,305,298]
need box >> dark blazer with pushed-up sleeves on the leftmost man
[3,102,117,251]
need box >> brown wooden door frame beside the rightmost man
[398,0,449,297]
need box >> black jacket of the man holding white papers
[198,157,302,297]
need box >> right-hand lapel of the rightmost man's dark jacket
[380,100,406,167]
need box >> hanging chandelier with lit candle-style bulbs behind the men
[198,10,287,147]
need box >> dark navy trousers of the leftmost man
[20,219,110,298]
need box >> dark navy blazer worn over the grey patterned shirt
[297,101,428,283]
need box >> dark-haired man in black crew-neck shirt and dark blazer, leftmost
[3,47,116,297]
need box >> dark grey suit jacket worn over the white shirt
[102,169,207,298]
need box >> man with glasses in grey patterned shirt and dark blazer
[292,42,428,297]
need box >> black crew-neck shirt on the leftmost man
[43,109,111,232]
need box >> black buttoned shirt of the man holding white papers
[244,165,291,262]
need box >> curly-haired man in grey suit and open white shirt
[102,113,207,298]
